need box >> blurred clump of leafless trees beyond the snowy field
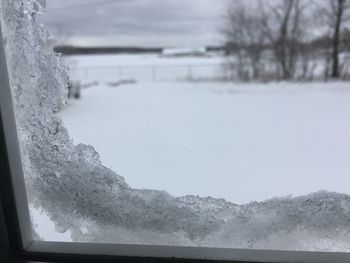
[223,0,350,80]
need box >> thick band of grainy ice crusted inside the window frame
[0,0,350,251]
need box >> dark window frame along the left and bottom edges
[0,21,350,263]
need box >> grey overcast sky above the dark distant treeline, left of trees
[40,0,230,47]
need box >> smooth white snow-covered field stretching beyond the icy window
[60,55,350,203]
